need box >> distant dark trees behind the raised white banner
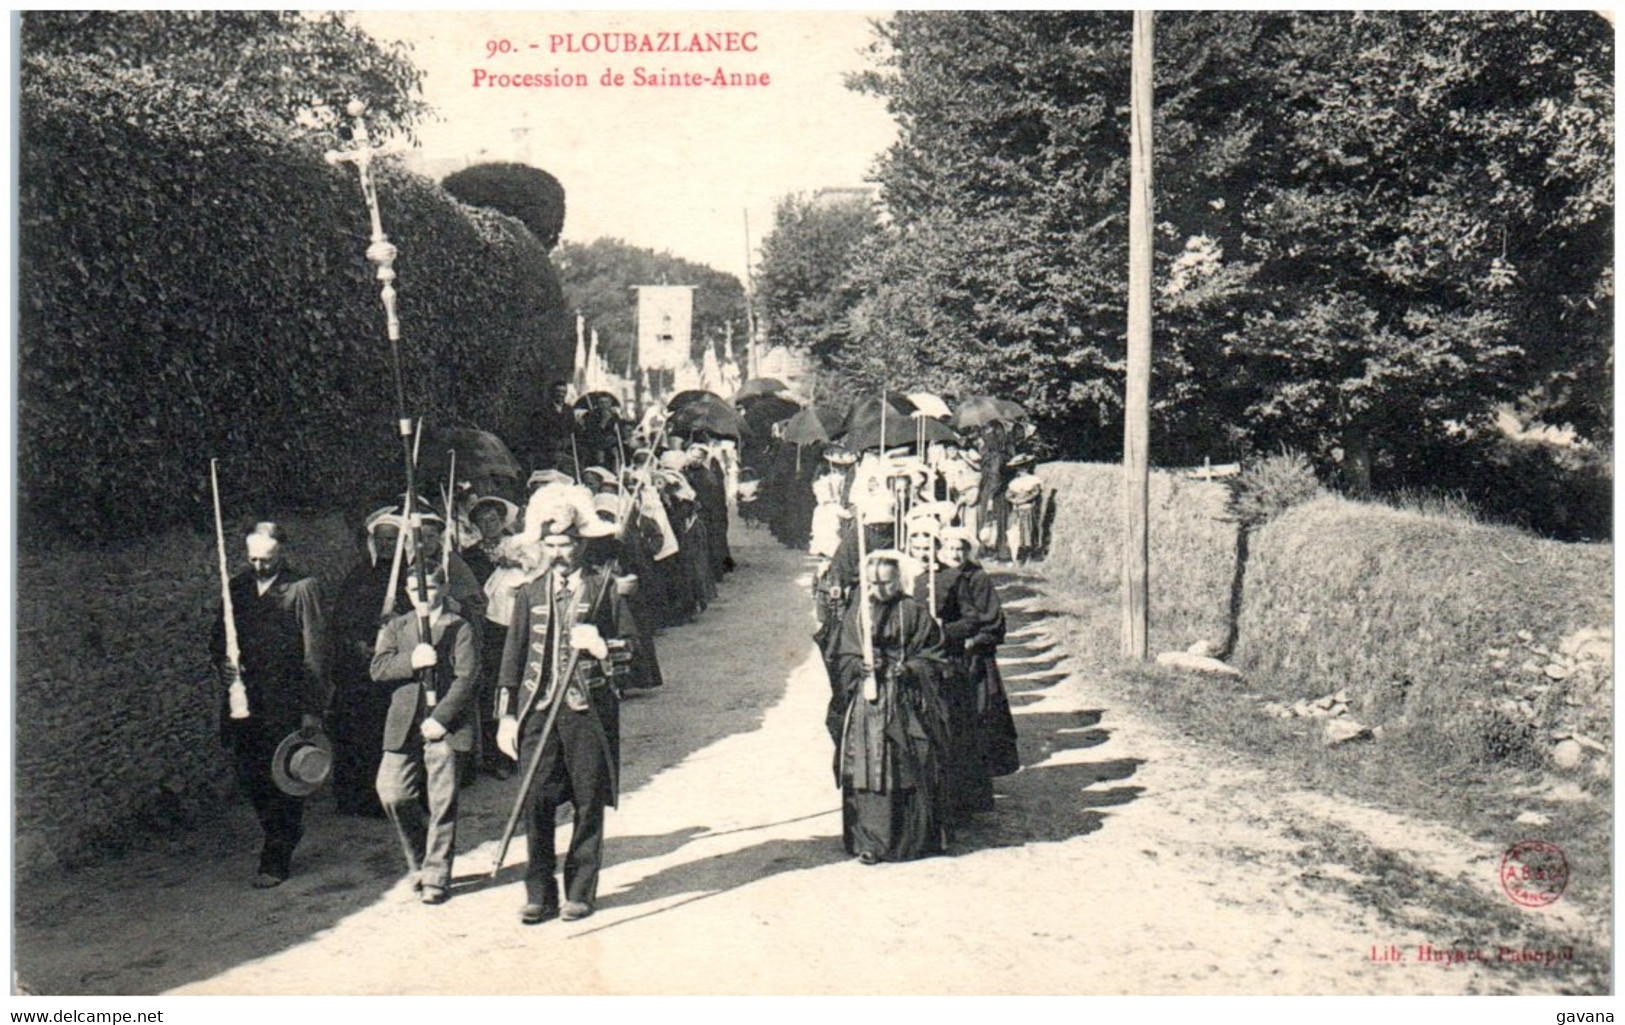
[553,239,744,370]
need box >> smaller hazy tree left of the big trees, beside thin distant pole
[756,195,879,357]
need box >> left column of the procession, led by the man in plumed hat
[211,385,738,923]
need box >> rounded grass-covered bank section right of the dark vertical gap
[1238,495,1614,760]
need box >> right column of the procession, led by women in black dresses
[741,398,1043,864]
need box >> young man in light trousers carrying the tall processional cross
[372,569,479,905]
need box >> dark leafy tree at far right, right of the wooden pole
[1225,11,1612,491]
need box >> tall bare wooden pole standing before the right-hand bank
[1123,11,1154,660]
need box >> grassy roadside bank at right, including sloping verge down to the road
[1037,465,1614,900]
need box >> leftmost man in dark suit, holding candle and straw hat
[211,523,332,890]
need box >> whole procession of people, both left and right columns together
[211,385,1042,924]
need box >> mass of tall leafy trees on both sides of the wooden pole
[827,11,1614,471]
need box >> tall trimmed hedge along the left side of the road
[18,60,574,539]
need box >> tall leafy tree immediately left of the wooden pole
[852,11,1212,455]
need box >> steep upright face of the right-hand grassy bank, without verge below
[1042,463,1614,768]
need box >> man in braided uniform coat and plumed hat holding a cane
[497,486,637,924]
